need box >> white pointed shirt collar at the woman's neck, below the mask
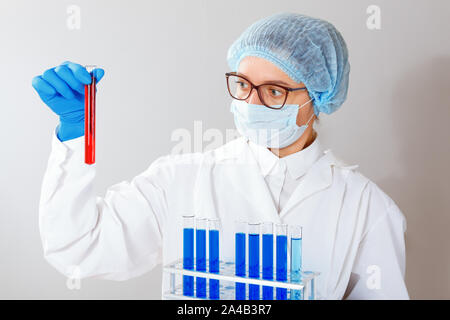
[248,137,323,179]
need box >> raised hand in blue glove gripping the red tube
[32,61,105,141]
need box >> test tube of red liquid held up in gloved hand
[84,65,96,164]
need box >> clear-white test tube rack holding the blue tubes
[163,259,320,300]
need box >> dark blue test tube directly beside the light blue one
[275,224,288,300]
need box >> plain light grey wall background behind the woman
[0,0,450,299]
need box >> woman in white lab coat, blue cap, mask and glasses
[33,13,409,299]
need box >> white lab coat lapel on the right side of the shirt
[280,151,334,218]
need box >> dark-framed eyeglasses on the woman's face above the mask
[225,72,306,109]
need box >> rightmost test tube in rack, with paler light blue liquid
[290,225,303,300]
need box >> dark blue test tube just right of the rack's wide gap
[235,221,247,300]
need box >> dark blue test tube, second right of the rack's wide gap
[248,223,261,300]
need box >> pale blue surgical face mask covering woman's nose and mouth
[231,99,314,148]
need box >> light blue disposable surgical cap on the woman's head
[227,12,350,115]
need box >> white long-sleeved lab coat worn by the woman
[39,128,409,299]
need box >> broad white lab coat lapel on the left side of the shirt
[194,138,280,223]
